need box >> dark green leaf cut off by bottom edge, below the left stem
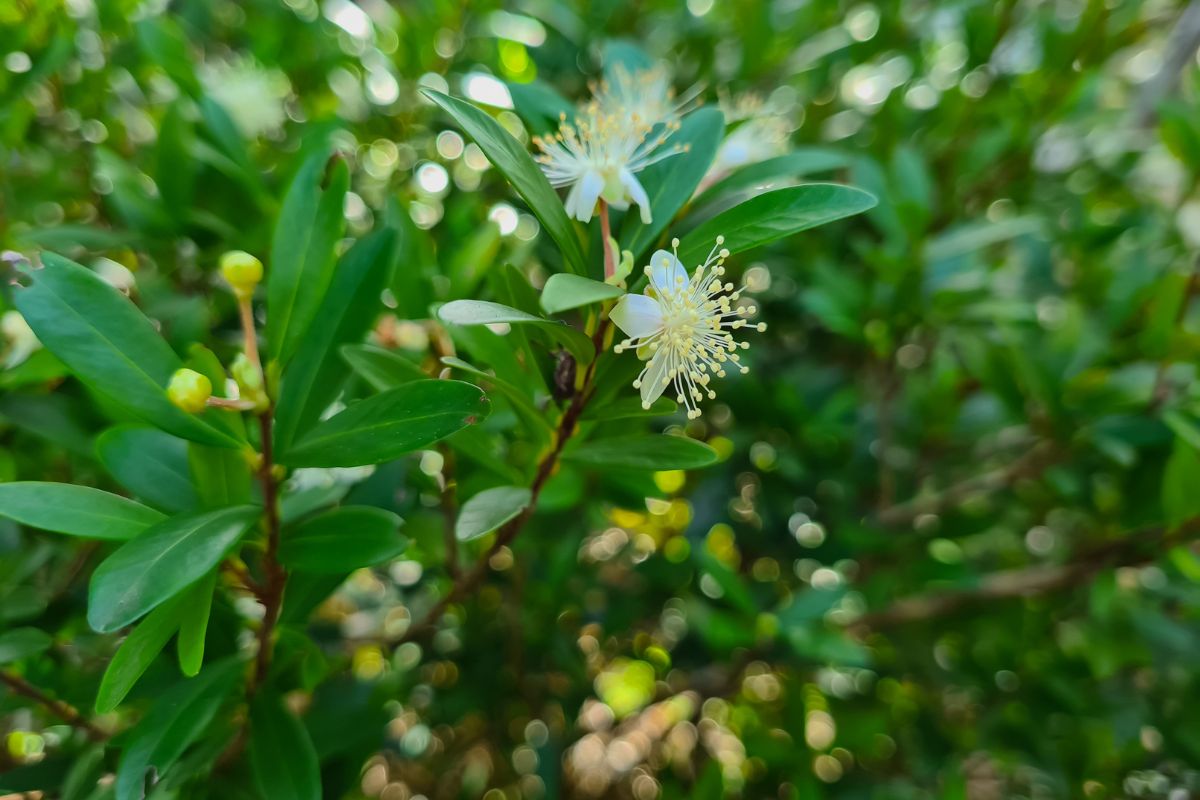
[250,694,320,800]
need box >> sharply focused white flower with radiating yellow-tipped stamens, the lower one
[608,236,767,419]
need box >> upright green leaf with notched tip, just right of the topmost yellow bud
[266,149,350,362]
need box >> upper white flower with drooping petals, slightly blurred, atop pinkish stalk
[534,103,684,224]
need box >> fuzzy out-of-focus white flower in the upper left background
[200,58,292,139]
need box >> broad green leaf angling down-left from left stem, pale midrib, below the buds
[88,506,262,633]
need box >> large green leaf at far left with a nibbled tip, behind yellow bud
[16,253,239,447]
